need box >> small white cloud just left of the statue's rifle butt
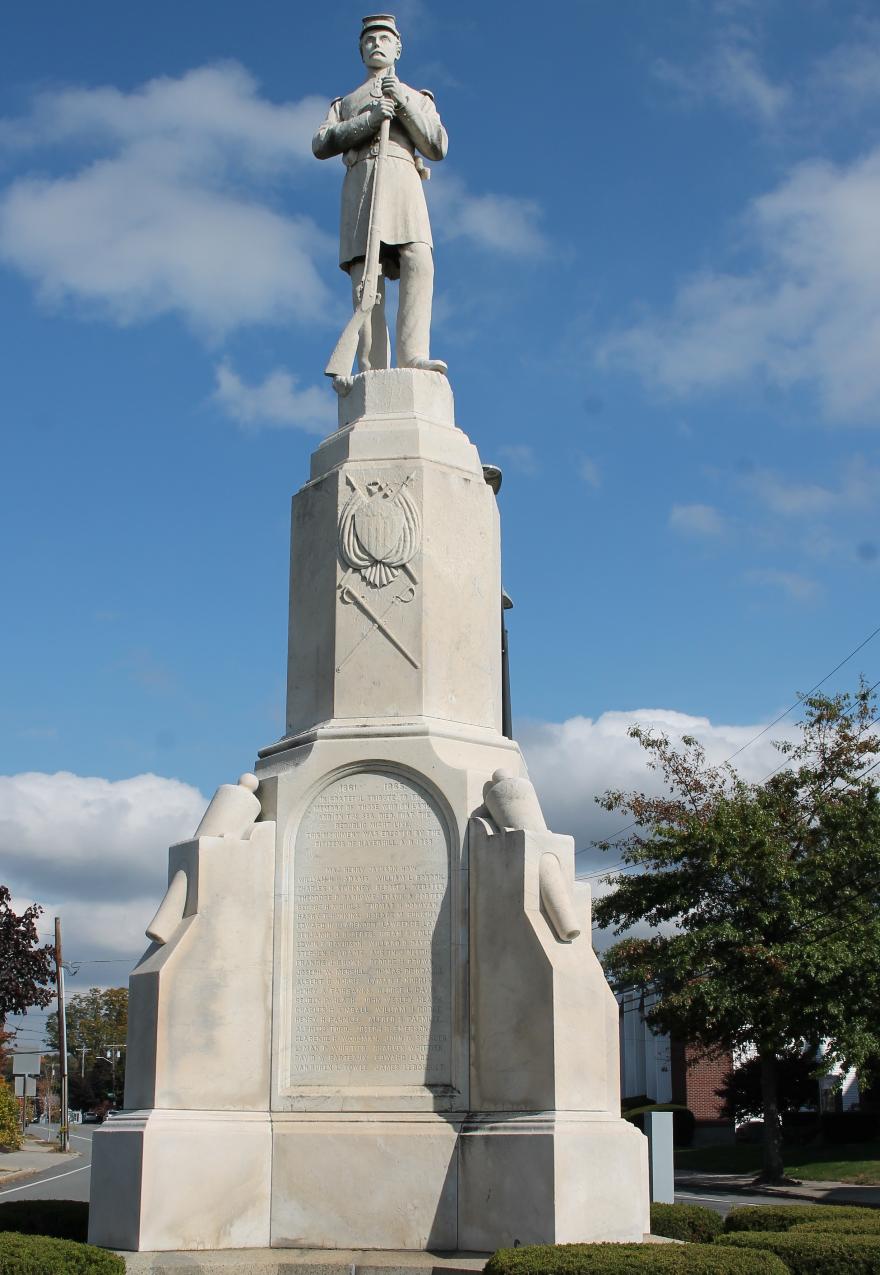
[214,362,337,434]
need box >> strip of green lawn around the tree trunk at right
[675,1142,880,1186]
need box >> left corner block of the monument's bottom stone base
[88,1111,272,1250]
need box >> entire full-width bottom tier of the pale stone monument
[89,1111,649,1249]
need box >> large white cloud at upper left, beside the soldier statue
[0,64,334,337]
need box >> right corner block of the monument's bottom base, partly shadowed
[458,1112,650,1250]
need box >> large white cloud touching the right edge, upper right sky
[599,148,880,425]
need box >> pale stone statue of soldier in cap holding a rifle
[311,13,448,372]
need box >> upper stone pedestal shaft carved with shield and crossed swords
[287,372,501,737]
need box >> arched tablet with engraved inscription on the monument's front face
[291,773,451,1086]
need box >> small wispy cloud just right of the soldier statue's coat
[429,170,548,258]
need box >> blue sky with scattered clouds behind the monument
[0,0,880,1030]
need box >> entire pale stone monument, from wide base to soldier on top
[89,14,649,1252]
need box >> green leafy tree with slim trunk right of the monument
[594,686,880,1181]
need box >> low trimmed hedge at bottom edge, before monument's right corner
[483,1244,788,1275]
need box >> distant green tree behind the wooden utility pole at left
[46,987,129,1105]
